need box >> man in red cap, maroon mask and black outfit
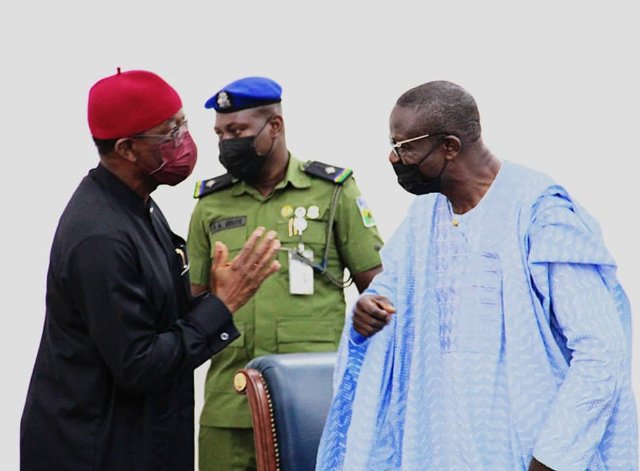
[20,70,280,471]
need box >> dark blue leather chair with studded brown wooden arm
[234,352,336,471]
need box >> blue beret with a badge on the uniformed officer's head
[204,77,282,113]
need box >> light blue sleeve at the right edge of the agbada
[529,195,627,471]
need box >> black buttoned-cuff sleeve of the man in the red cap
[68,237,240,394]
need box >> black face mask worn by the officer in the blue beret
[218,120,275,182]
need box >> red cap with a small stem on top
[87,68,182,139]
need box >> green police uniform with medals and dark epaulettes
[187,155,382,469]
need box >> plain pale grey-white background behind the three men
[0,0,640,470]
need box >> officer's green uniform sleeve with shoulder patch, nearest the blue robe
[334,177,383,273]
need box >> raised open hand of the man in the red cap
[210,227,280,313]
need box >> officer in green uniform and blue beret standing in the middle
[187,77,382,471]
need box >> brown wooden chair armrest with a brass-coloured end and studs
[233,368,280,471]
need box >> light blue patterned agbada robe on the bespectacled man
[317,162,638,471]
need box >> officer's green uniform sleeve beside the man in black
[187,201,211,286]
